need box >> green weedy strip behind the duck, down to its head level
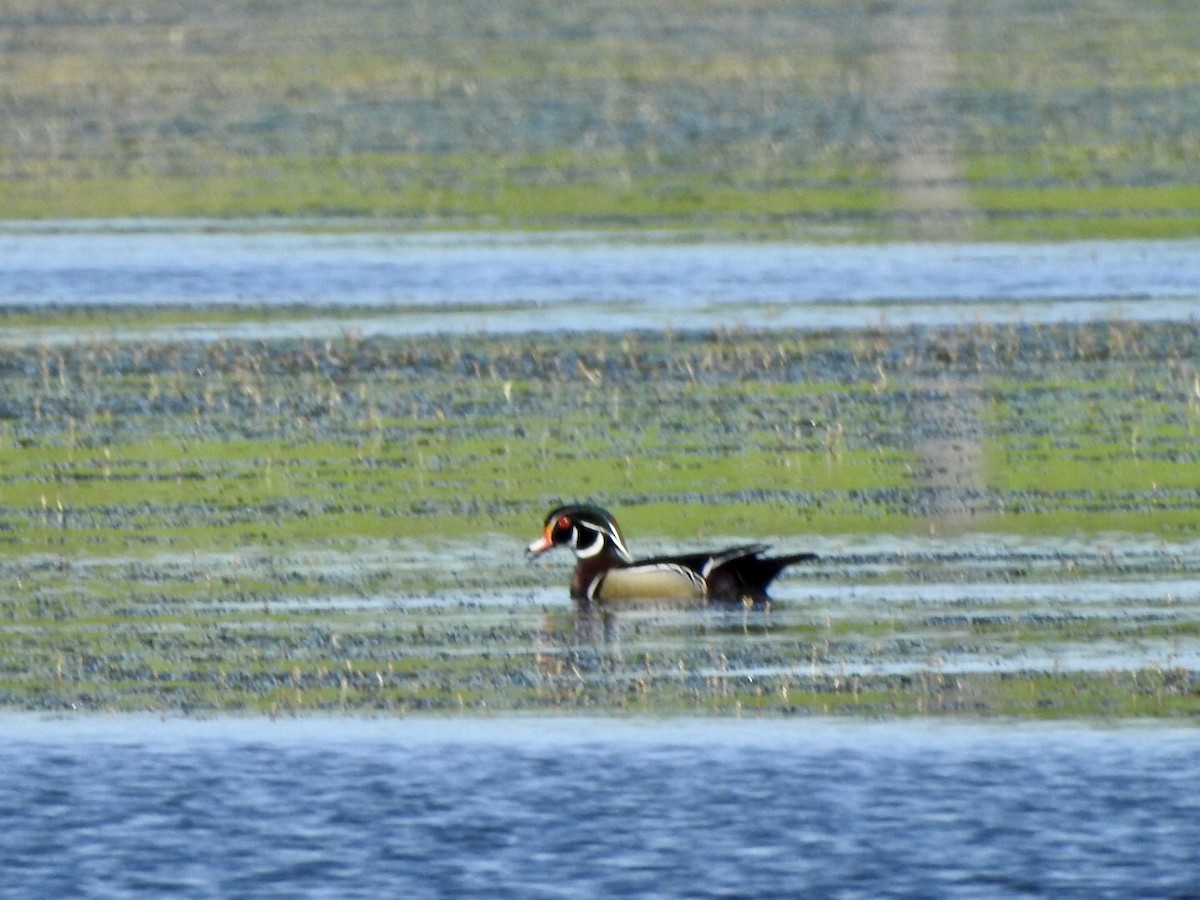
[0,311,1198,553]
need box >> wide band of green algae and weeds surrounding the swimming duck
[0,321,1200,718]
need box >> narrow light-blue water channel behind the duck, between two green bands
[0,222,1200,340]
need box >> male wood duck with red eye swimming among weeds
[526,505,816,605]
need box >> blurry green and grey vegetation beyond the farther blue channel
[7,0,1200,240]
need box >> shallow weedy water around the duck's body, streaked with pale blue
[11,534,1200,718]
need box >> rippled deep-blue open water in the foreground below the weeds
[0,716,1200,898]
